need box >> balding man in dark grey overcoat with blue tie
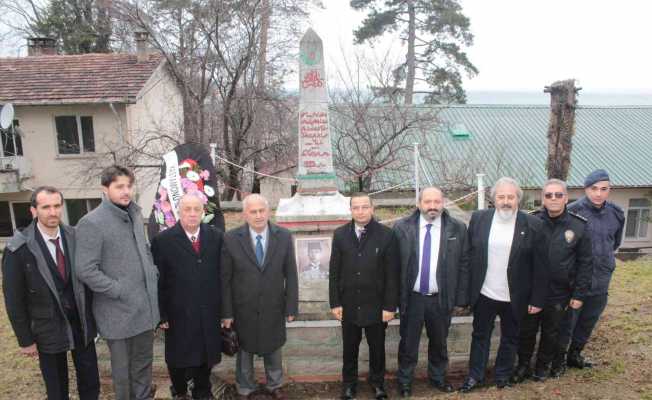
[222,194,299,399]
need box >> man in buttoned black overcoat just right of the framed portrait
[329,193,399,400]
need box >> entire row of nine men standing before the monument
[2,166,624,400]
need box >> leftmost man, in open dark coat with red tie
[2,186,100,400]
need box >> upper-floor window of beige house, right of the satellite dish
[54,115,95,154]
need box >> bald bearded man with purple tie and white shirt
[394,187,466,397]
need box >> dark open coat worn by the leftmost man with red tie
[2,222,97,353]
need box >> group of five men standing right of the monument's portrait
[329,170,624,399]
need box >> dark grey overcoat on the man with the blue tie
[222,223,299,354]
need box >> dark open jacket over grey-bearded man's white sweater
[460,209,548,318]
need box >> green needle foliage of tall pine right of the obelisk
[350,0,478,104]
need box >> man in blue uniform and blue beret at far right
[558,169,625,369]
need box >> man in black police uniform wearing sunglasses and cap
[512,179,592,383]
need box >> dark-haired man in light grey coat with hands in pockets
[76,165,160,400]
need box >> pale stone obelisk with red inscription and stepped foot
[276,29,351,232]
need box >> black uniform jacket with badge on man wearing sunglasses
[534,208,593,303]
